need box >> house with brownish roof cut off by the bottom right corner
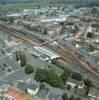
[88,89,99,100]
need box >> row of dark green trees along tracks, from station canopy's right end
[52,59,93,89]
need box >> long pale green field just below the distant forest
[0,1,78,10]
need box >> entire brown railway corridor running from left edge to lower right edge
[0,24,99,82]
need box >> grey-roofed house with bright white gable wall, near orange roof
[17,81,39,95]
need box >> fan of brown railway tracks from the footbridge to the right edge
[45,41,99,82]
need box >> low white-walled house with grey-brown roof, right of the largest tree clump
[67,79,84,89]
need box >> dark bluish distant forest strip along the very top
[0,0,99,6]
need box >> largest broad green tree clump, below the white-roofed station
[35,69,64,88]
